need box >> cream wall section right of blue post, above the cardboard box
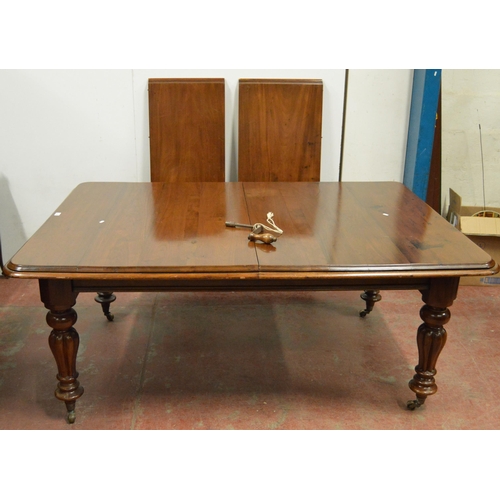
[441,69,500,214]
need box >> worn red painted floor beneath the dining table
[0,278,500,430]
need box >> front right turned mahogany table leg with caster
[407,278,458,410]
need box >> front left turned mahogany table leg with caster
[40,280,83,424]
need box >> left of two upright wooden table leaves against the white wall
[148,78,225,182]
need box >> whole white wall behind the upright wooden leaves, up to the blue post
[0,69,412,261]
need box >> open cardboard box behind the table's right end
[446,189,500,286]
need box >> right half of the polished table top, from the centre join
[244,182,492,272]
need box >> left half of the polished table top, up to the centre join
[7,182,257,274]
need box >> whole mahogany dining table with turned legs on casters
[4,182,498,423]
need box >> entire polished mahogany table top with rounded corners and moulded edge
[6,182,498,279]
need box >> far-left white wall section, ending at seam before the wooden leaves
[0,70,137,266]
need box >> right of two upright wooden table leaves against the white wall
[238,79,323,182]
